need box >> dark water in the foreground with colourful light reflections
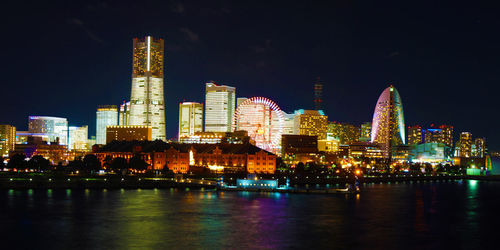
[0,180,500,249]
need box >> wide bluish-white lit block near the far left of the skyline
[28,116,68,145]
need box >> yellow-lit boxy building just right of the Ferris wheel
[294,109,328,140]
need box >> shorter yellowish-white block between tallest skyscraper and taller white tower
[178,102,203,139]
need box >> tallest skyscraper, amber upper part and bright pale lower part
[128,36,166,141]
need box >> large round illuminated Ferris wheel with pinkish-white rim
[233,97,285,153]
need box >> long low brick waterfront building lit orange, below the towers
[94,141,276,174]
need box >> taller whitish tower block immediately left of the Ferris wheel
[205,82,236,132]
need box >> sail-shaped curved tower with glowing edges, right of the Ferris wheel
[371,85,406,157]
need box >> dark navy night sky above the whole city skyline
[0,0,500,150]
